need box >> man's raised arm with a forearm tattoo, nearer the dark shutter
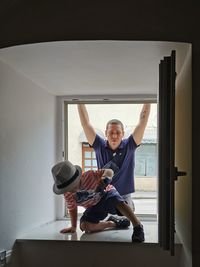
[133,103,151,145]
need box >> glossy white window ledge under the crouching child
[18,220,158,243]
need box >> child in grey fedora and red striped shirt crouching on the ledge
[52,161,144,242]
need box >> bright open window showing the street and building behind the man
[64,99,158,223]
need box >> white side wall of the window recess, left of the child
[0,61,56,250]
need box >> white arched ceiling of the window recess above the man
[0,41,190,96]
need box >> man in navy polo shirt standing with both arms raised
[78,103,151,240]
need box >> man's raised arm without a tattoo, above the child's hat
[78,104,96,145]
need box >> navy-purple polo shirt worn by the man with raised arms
[92,135,137,195]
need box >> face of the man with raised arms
[105,124,124,150]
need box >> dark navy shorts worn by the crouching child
[80,189,126,223]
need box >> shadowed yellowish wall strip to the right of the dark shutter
[175,47,192,267]
